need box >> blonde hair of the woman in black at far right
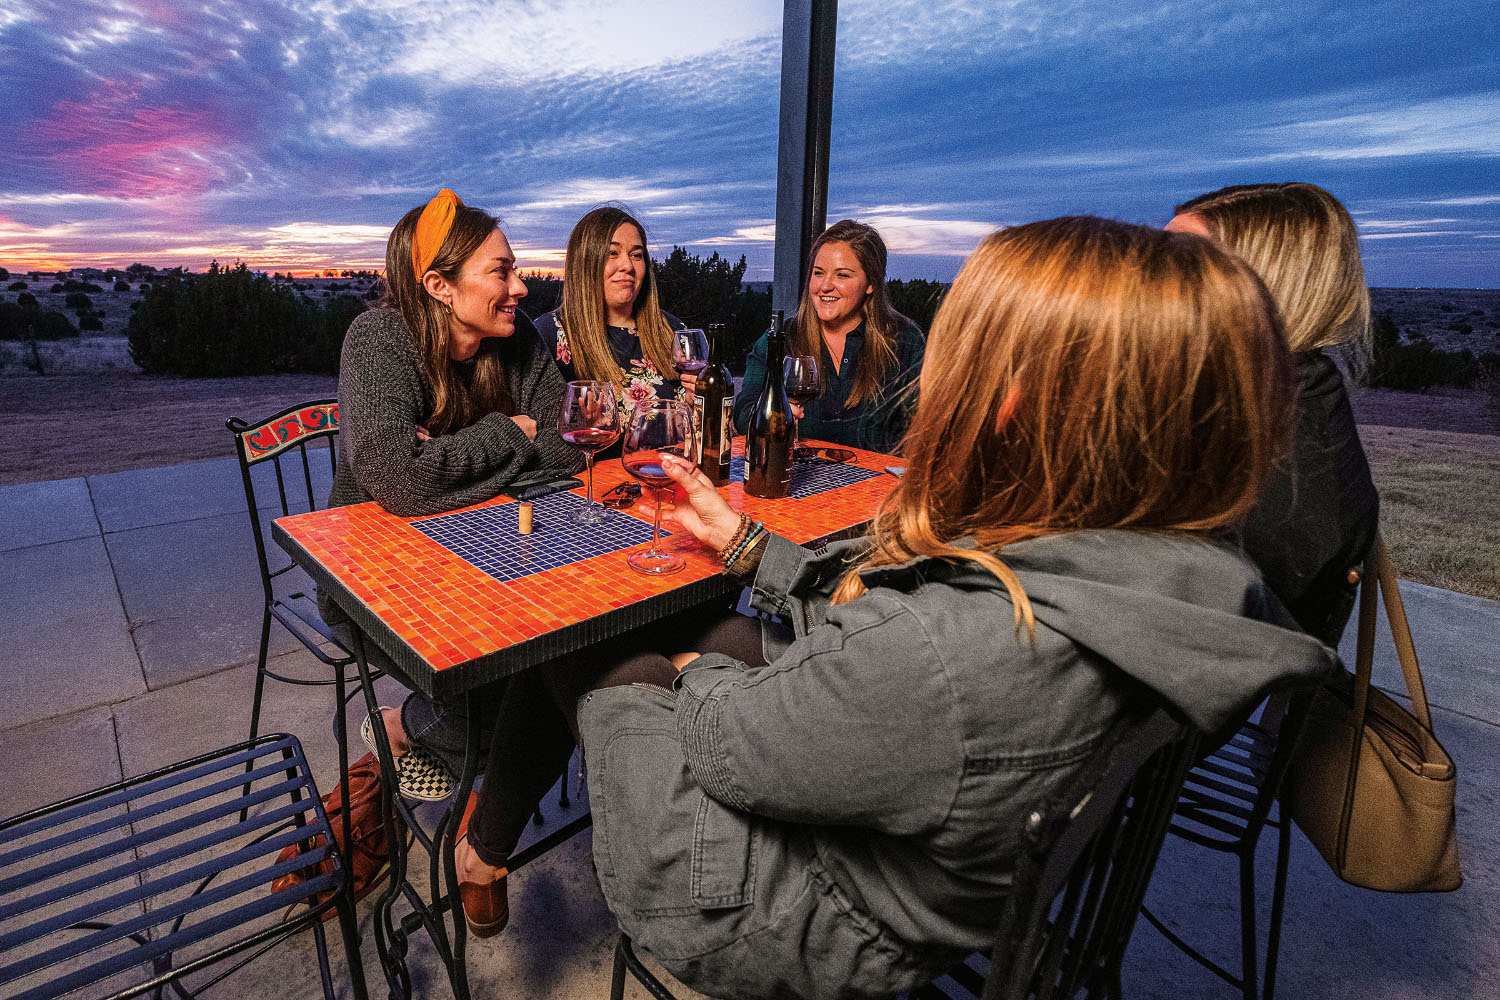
[1176,181,1370,361]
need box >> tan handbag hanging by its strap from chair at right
[1283,534,1464,892]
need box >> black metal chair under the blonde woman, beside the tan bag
[1142,691,1311,1000]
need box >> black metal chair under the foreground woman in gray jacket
[611,711,1197,1000]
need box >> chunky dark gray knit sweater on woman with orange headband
[329,309,584,517]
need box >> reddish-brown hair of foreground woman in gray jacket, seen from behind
[834,216,1295,627]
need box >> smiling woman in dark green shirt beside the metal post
[735,219,926,453]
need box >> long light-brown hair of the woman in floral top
[558,205,678,385]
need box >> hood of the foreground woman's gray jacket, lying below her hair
[861,531,1338,732]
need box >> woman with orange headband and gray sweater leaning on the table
[318,189,584,924]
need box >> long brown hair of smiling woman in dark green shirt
[791,219,902,406]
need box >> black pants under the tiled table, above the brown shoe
[468,610,765,867]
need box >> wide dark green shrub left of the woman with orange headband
[128,261,365,376]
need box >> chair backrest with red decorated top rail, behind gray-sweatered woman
[225,399,339,600]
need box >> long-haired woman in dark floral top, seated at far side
[537,205,693,408]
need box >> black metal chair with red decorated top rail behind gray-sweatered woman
[225,399,380,779]
